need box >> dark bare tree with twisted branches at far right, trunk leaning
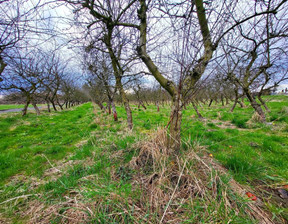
[218,1,288,122]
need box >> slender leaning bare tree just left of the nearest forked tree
[66,0,141,129]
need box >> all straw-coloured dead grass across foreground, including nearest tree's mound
[0,129,275,224]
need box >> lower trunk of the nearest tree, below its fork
[167,95,182,154]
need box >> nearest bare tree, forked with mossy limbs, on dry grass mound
[137,0,285,152]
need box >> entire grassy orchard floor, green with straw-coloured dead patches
[0,96,288,223]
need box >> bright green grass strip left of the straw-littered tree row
[0,105,92,183]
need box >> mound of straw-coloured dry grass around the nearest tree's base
[130,129,272,223]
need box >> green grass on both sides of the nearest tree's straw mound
[0,96,288,223]
